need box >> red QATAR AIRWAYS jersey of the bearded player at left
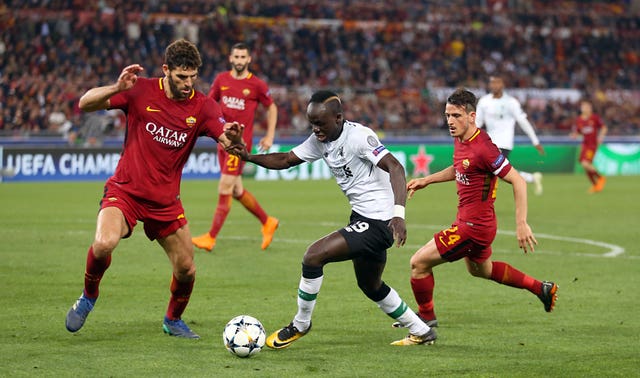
[109,78,226,207]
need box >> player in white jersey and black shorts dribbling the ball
[226,91,436,349]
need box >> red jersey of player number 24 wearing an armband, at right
[453,129,511,227]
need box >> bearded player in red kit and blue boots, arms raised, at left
[66,40,241,338]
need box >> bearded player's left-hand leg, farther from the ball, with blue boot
[65,204,129,332]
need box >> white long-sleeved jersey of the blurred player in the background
[476,93,540,150]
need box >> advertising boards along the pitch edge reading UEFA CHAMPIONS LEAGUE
[0,138,640,183]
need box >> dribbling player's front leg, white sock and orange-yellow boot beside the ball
[266,232,352,349]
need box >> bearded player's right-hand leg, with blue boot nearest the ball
[156,224,200,339]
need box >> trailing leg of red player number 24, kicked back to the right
[465,257,558,312]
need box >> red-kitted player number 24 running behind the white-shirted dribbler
[395,89,558,344]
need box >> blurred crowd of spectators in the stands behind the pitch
[0,0,640,141]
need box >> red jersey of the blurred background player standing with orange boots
[209,71,273,151]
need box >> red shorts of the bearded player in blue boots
[100,183,187,240]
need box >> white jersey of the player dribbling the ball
[292,121,394,220]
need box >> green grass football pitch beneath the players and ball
[0,175,640,377]
